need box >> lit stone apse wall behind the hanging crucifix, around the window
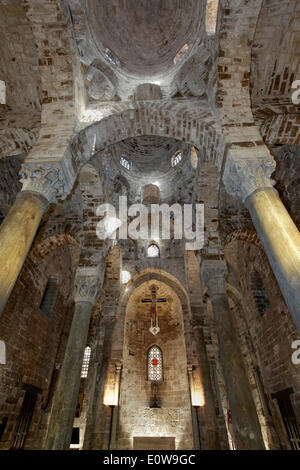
[117,281,193,449]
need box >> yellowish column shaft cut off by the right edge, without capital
[245,189,300,333]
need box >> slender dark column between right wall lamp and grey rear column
[194,324,220,450]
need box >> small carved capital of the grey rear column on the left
[74,267,101,304]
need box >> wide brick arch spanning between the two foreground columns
[62,106,226,194]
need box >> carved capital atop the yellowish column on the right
[223,153,276,202]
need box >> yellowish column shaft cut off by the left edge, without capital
[0,191,48,315]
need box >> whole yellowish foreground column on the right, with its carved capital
[223,155,300,333]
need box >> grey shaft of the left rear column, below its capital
[46,302,92,450]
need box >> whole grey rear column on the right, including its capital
[201,260,265,450]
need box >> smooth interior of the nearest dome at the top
[89,0,203,77]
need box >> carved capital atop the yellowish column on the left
[20,163,69,203]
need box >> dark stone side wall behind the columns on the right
[225,232,300,448]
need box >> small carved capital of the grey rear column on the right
[201,259,227,297]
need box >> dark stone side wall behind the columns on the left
[0,237,78,449]
